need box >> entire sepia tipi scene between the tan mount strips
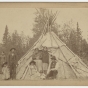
[0,2,88,85]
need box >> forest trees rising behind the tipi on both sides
[0,8,88,64]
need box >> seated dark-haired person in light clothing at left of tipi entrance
[29,61,40,80]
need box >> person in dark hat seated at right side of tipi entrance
[46,55,59,79]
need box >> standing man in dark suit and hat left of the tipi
[8,48,17,80]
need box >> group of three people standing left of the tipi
[0,48,17,80]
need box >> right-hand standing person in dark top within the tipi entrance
[42,47,49,74]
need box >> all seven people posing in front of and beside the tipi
[0,47,59,80]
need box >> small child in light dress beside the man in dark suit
[2,62,10,80]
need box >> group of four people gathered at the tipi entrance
[29,47,59,79]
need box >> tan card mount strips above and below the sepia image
[0,2,88,86]
